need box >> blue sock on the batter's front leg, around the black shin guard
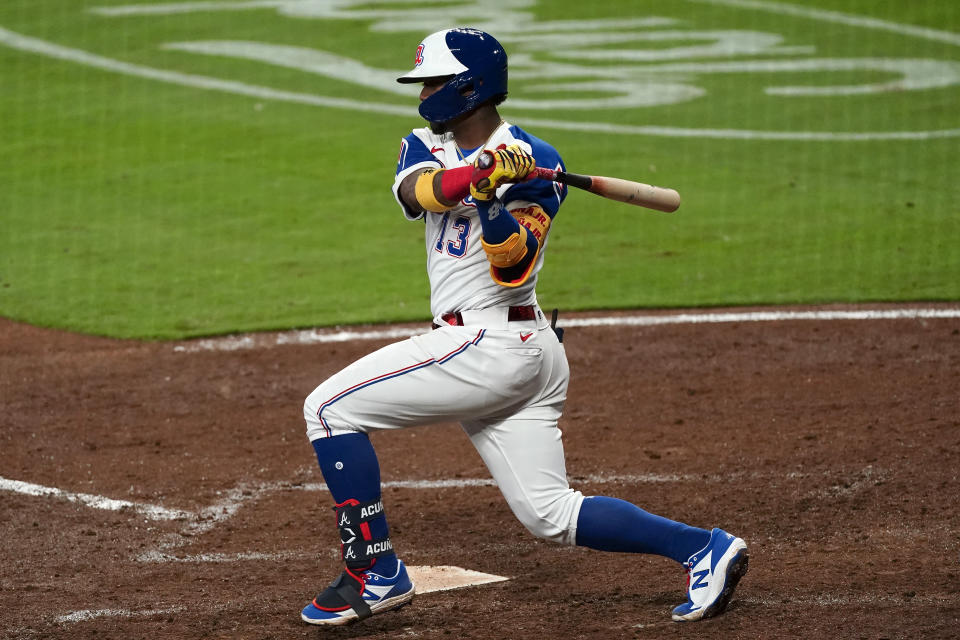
[311,433,397,576]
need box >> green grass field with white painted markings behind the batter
[0,0,960,338]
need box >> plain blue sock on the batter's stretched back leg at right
[577,496,710,562]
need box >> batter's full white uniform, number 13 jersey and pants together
[303,124,583,545]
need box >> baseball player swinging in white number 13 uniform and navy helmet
[301,29,747,625]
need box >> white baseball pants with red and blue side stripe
[304,308,583,545]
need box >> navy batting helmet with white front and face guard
[397,29,507,123]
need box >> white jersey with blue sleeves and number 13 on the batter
[393,122,567,318]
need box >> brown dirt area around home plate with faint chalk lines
[0,305,960,640]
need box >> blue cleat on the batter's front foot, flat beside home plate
[300,560,414,625]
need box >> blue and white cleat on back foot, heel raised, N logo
[672,529,749,622]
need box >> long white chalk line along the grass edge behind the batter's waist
[173,308,960,353]
